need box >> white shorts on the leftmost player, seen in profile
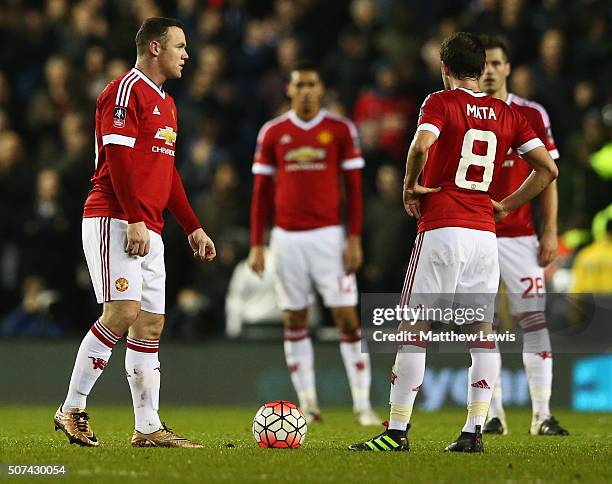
[82,217,166,314]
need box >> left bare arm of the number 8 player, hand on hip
[404,130,440,218]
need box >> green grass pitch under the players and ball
[0,406,612,483]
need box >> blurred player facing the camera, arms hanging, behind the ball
[249,63,380,425]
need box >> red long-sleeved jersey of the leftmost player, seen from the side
[83,68,178,233]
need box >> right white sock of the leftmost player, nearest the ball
[125,336,162,434]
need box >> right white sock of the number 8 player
[462,347,499,433]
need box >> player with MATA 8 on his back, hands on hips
[349,32,557,452]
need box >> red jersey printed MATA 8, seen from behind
[417,88,542,236]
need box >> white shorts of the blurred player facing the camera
[270,226,357,311]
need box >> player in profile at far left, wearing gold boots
[54,18,215,447]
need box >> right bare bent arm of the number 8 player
[494,146,559,219]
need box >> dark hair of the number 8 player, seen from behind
[440,32,486,79]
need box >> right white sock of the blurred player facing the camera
[340,329,372,413]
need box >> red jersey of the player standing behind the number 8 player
[489,94,559,237]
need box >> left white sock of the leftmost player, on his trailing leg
[62,321,119,411]
